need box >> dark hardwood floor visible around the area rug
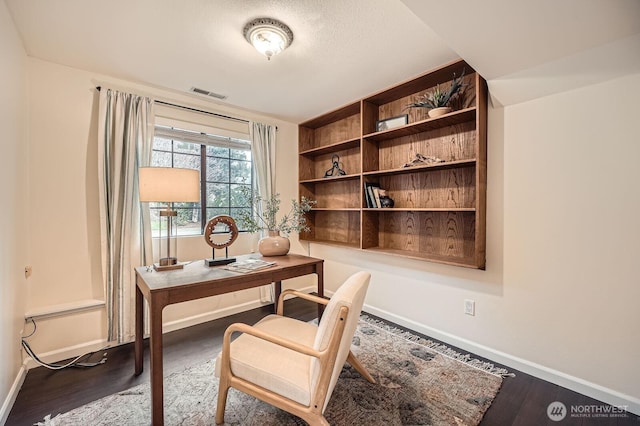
[6,299,640,426]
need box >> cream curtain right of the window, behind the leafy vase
[249,123,276,302]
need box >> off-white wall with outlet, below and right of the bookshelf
[311,75,640,412]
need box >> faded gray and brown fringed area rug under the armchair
[38,315,508,426]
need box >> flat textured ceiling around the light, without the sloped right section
[6,0,457,122]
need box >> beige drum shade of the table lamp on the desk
[139,167,200,203]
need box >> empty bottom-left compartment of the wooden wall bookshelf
[300,209,360,247]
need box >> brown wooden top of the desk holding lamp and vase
[135,253,324,291]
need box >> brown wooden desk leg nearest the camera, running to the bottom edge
[149,295,164,426]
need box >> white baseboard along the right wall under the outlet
[363,305,640,415]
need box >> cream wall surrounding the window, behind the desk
[25,58,312,360]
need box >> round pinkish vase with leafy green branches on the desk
[237,188,316,256]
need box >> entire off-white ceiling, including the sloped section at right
[5,0,640,122]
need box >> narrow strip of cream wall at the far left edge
[0,2,29,424]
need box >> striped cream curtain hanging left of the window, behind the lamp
[98,88,154,343]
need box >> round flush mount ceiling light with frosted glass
[242,18,293,60]
